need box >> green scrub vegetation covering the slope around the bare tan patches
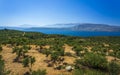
[0,29,120,75]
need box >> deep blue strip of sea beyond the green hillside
[0,28,120,37]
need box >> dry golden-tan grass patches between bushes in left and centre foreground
[1,45,75,75]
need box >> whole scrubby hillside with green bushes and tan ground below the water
[0,29,120,75]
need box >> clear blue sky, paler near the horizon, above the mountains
[0,0,120,26]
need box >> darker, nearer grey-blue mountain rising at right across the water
[68,23,120,32]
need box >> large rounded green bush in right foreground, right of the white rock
[76,53,107,70]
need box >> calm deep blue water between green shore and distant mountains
[24,28,120,36]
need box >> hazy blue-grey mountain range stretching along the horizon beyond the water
[0,23,120,32]
